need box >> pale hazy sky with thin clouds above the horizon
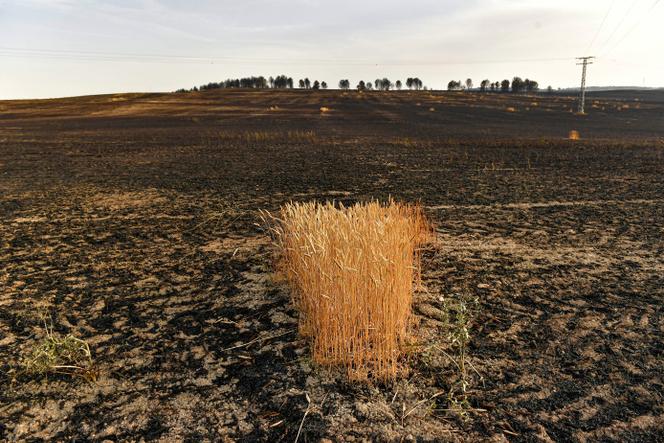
[0,0,664,99]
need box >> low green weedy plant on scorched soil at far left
[22,323,97,380]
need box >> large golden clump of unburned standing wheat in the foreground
[274,201,430,380]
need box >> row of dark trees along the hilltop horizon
[176,75,552,93]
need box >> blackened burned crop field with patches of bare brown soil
[0,91,664,441]
